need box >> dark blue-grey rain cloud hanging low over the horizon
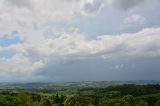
[36,57,160,82]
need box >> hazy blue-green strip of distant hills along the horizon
[0,80,160,89]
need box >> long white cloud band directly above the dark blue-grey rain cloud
[8,28,160,58]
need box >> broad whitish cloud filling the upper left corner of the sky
[0,0,104,37]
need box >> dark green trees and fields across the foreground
[0,84,160,106]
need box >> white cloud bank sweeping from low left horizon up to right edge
[0,28,160,79]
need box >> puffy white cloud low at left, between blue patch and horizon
[0,54,43,82]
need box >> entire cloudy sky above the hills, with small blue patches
[0,0,160,82]
